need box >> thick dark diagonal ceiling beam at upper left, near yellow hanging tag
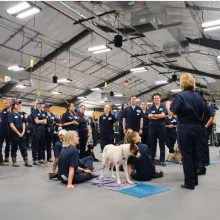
[27,29,91,72]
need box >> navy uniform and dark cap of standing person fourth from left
[43,103,56,162]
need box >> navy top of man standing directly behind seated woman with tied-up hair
[123,105,143,132]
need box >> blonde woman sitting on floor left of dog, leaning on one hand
[58,131,93,189]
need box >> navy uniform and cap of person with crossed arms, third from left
[31,100,46,165]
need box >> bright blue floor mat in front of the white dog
[117,183,169,198]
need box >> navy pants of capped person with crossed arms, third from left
[32,126,44,162]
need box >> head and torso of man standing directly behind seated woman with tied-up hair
[123,95,144,135]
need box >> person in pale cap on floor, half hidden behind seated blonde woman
[49,129,67,179]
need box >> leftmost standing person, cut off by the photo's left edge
[0,99,11,166]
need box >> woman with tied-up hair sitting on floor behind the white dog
[126,131,163,181]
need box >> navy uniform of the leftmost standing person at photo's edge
[0,108,11,163]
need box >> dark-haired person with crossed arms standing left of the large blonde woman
[147,93,167,166]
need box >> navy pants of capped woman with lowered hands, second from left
[10,134,28,160]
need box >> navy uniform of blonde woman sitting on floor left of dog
[58,146,92,184]
